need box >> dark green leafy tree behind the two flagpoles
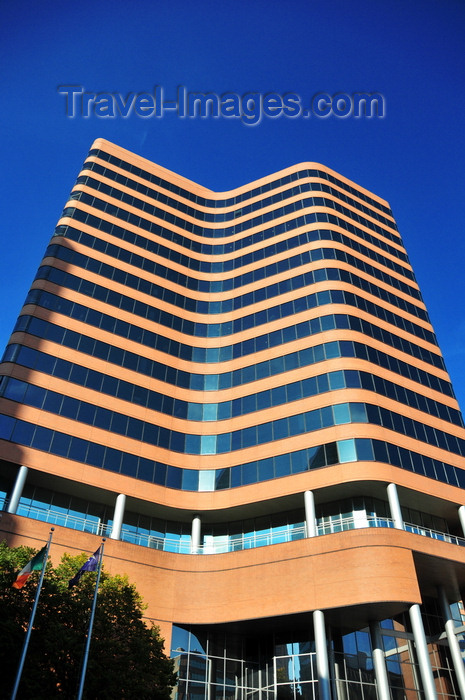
[0,542,176,700]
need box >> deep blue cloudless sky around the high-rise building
[0,0,465,408]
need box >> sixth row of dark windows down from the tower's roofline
[54,224,422,300]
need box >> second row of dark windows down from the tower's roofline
[84,161,398,227]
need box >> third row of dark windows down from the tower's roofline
[70,175,400,243]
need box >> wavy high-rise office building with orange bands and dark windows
[0,139,465,700]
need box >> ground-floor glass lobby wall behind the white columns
[171,601,461,700]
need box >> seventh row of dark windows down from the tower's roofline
[45,238,429,320]
